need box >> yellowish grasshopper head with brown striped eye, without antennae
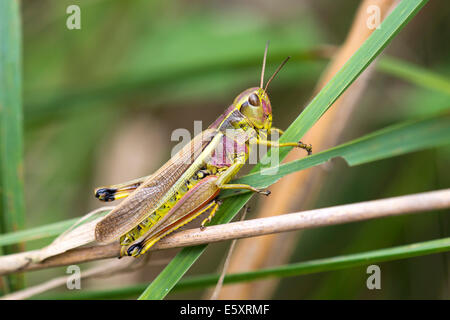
[233,87,272,130]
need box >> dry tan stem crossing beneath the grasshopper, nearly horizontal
[0,189,450,275]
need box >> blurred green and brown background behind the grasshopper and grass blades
[12,0,450,299]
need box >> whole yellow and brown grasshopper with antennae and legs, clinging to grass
[95,45,312,257]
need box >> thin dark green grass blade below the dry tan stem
[43,238,450,300]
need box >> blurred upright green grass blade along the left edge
[0,0,25,291]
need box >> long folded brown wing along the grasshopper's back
[95,129,217,243]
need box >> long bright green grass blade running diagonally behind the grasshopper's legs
[139,0,427,299]
